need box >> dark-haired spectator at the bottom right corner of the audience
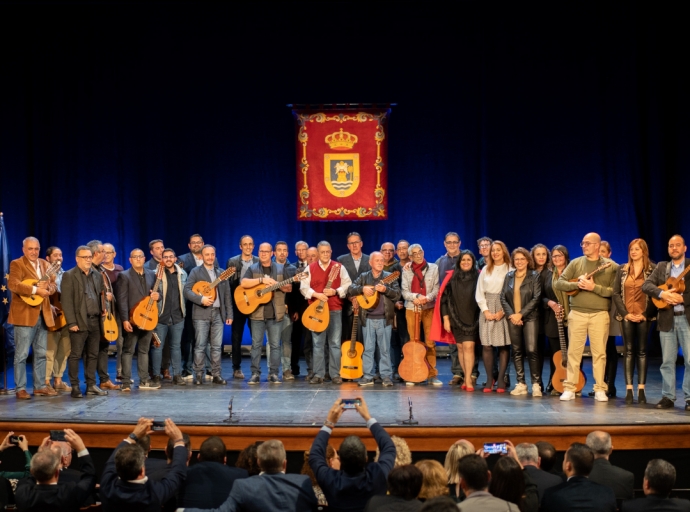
[621,459,690,512]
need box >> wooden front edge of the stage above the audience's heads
[5,420,690,452]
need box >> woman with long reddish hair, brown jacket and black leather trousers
[613,238,656,404]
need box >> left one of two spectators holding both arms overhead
[100,418,188,512]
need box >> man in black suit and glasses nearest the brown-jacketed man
[61,245,112,398]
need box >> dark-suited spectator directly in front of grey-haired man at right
[541,443,617,512]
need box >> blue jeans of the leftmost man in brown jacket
[14,320,48,391]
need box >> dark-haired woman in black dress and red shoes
[441,250,479,391]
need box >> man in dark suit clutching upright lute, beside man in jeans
[115,249,160,393]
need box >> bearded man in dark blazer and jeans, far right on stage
[642,235,690,411]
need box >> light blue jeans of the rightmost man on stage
[659,315,690,400]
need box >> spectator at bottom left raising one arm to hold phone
[15,428,96,512]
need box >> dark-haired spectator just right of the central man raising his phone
[364,463,422,512]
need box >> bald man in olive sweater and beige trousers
[554,233,618,402]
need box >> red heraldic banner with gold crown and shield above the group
[293,109,390,220]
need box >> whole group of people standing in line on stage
[8,232,690,410]
